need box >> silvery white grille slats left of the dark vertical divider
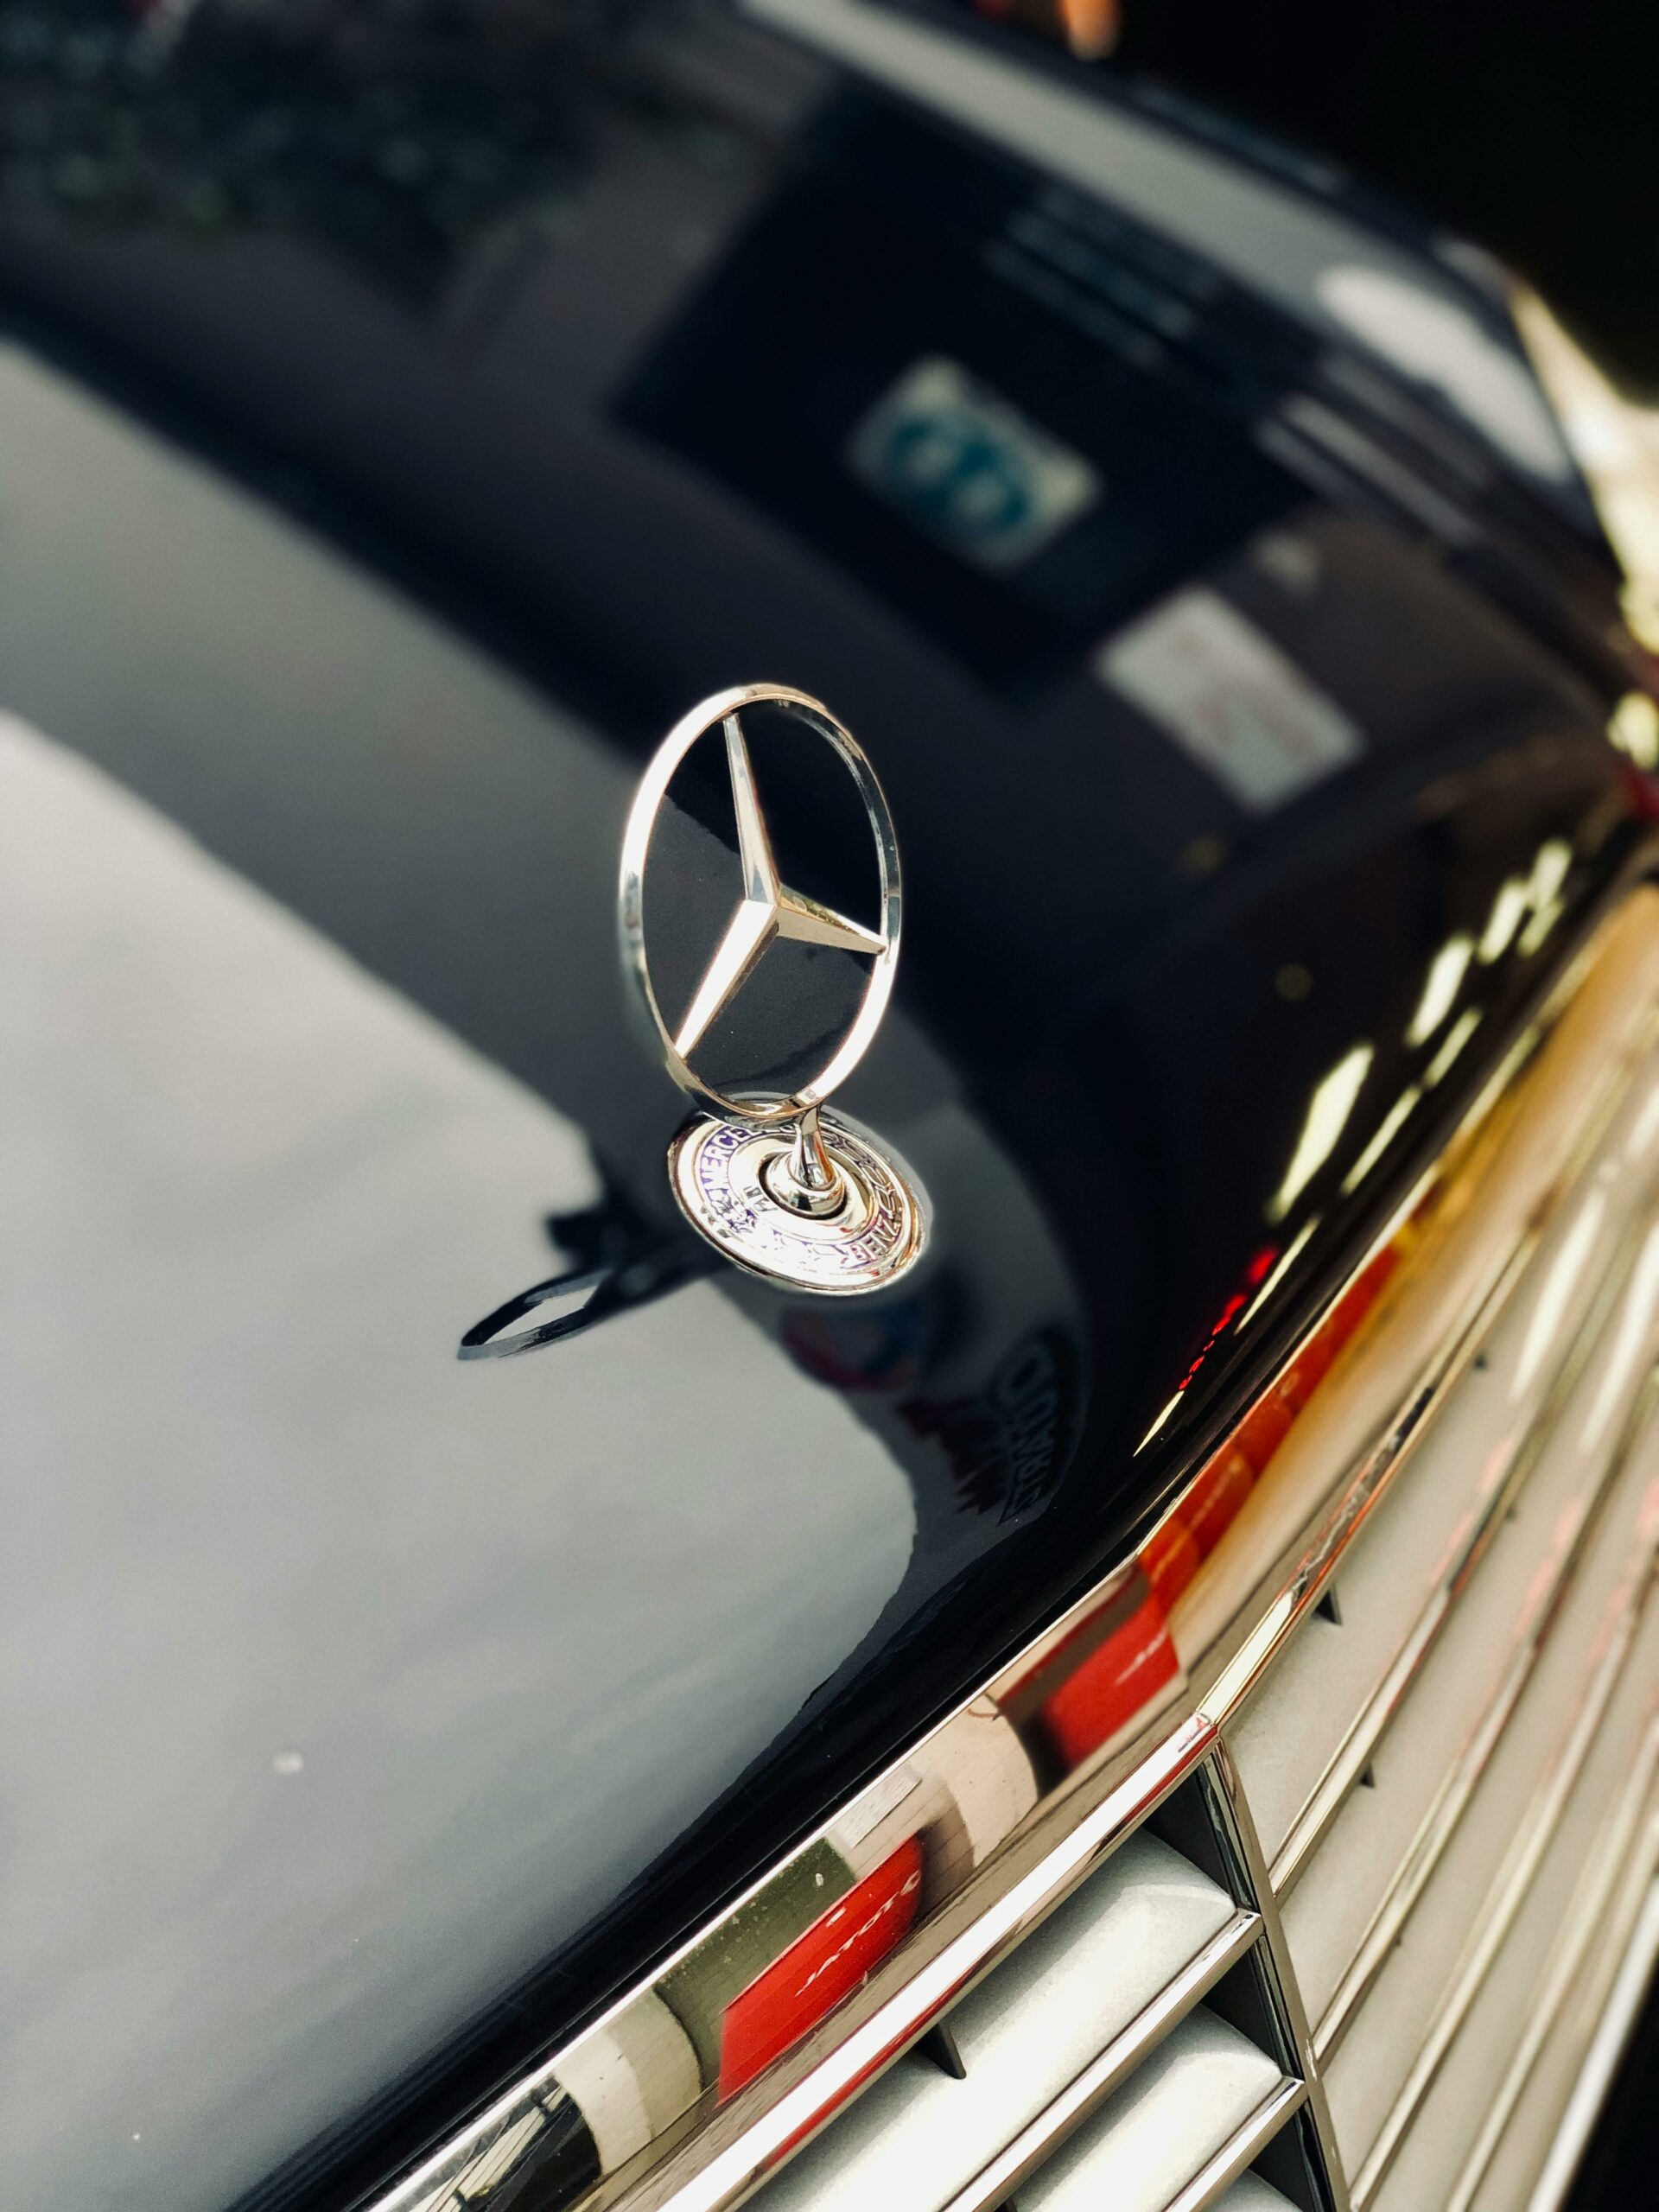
[754,1774,1327,2212]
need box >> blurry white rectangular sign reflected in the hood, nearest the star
[1095,588,1365,814]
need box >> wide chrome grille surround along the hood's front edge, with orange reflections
[374,887,1659,2212]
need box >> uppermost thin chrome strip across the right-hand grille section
[1272,1176,1646,1900]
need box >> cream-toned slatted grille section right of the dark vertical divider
[1232,1039,1659,2212]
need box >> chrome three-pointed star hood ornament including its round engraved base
[620,683,927,1296]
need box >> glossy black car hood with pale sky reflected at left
[0,11,1639,2212]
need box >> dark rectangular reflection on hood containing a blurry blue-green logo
[620,93,1307,686]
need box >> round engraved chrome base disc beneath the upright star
[668,1113,927,1299]
